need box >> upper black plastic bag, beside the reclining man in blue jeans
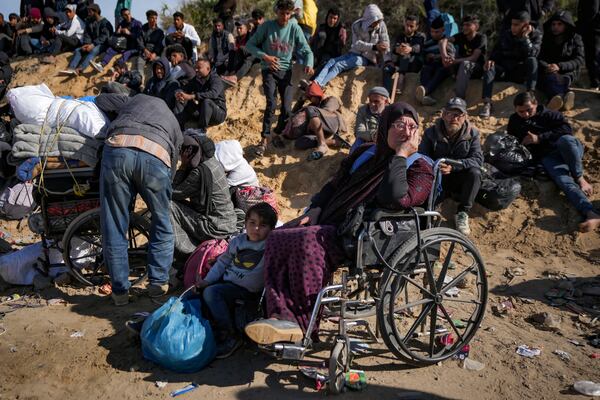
[483,133,531,175]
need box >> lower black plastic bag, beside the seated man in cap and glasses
[475,164,521,211]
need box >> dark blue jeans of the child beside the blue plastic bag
[202,282,259,335]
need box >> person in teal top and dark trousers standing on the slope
[246,0,314,156]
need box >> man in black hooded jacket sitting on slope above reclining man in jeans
[539,11,585,111]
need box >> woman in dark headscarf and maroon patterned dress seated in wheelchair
[245,102,434,344]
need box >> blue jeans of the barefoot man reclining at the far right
[542,135,594,216]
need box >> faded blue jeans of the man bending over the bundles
[100,145,175,294]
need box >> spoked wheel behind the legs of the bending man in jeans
[62,208,150,286]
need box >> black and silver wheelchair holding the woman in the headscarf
[259,159,488,394]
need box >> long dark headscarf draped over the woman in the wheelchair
[319,102,419,225]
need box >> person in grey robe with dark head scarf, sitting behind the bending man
[170,129,237,259]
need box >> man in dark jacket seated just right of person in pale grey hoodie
[383,15,426,93]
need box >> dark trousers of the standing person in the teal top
[261,69,293,137]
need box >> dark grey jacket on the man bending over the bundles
[96,94,183,175]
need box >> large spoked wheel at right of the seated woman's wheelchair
[377,228,487,366]
